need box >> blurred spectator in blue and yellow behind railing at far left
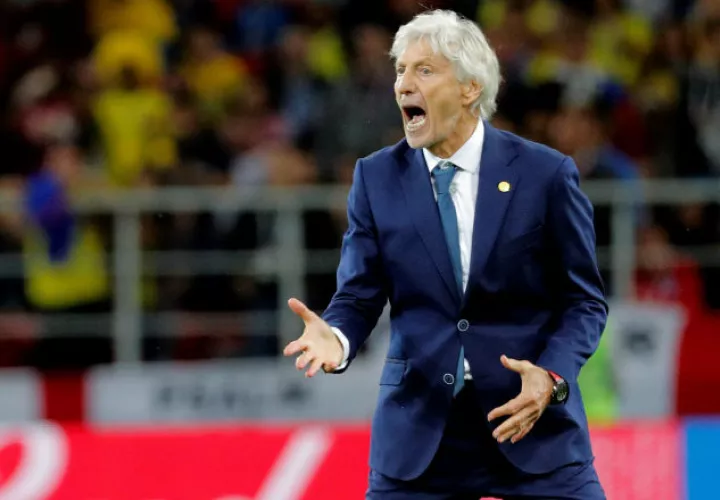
[23,143,111,369]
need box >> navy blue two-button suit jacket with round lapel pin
[323,123,607,480]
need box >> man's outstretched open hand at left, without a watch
[283,299,344,377]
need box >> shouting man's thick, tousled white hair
[390,10,502,119]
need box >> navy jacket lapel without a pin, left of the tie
[400,145,460,302]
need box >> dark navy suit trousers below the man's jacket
[366,383,605,500]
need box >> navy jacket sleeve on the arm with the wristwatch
[537,157,608,382]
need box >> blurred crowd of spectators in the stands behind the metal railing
[0,0,720,368]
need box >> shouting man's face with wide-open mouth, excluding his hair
[395,40,473,148]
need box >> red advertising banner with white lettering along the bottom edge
[0,424,682,500]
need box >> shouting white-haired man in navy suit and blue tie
[285,11,607,500]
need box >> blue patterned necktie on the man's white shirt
[432,161,465,396]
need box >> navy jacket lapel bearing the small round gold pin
[465,122,518,304]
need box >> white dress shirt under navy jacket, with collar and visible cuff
[332,120,485,380]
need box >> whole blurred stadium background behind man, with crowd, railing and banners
[0,0,720,500]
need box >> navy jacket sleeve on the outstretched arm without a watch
[323,160,387,373]
